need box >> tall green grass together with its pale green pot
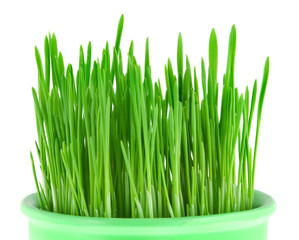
[21,16,275,240]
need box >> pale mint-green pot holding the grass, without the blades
[21,191,275,240]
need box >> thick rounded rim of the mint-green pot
[21,190,276,235]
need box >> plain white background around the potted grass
[0,0,299,240]
